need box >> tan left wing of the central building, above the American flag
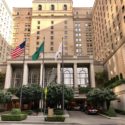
[12,8,32,54]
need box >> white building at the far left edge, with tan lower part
[0,0,12,62]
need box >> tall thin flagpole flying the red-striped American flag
[20,38,26,109]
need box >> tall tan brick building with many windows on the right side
[92,0,125,79]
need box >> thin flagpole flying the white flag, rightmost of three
[61,37,64,113]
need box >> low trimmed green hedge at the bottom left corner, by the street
[1,113,27,121]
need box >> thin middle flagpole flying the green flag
[41,37,45,113]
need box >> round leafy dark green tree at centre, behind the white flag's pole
[47,84,73,108]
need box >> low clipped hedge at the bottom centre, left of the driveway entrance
[45,116,65,122]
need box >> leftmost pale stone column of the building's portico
[4,63,12,89]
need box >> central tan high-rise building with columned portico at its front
[5,0,95,94]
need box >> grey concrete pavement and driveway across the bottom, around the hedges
[0,111,125,125]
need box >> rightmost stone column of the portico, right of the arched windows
[90,63,95,88]
